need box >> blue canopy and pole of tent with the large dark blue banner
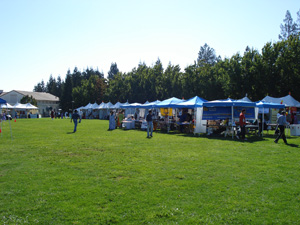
[203,98,256,138]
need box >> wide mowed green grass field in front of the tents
[0,118,300,224]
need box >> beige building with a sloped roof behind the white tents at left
[0,90,59,117]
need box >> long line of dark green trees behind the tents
[34,10,300,110]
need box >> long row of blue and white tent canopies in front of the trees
[78,95,300,137]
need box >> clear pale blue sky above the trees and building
[0,0,300,92]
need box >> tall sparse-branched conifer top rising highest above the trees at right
[278,10,298,40]
